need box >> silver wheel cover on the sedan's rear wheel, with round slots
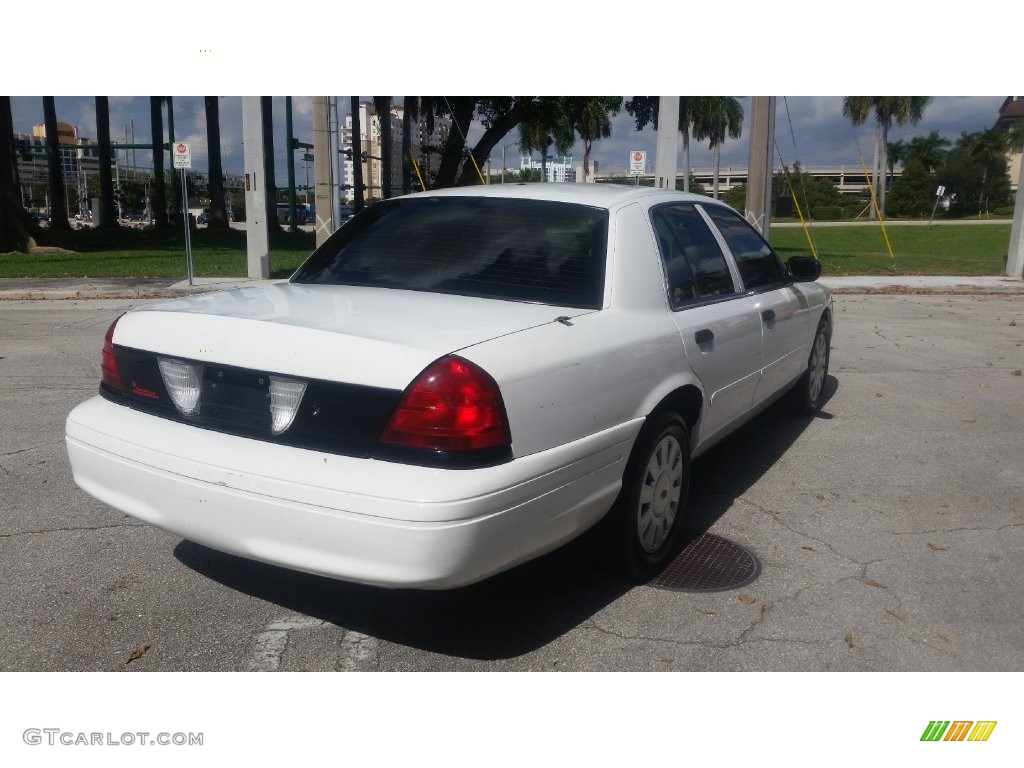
[637,435,683,554]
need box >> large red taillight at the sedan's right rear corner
[380,357,509,453]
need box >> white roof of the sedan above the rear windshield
[395,182,717,208]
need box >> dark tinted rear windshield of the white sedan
[292,197,608,309]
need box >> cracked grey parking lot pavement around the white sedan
[0,295,1024,671]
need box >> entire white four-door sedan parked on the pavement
[67,184,833,589]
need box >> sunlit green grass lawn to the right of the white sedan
[771,221,1010,275]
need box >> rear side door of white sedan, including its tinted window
[650,203,761,442]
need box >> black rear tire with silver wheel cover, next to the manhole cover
[606,413,690,582]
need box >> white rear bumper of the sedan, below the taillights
[67,397,640,588]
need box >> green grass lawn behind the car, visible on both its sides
[0,221,1010,280]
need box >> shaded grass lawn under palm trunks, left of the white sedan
[0,229,315,280]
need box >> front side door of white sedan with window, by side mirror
[701,205,812,404]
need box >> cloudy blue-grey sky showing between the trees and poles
[11,95,1005,183]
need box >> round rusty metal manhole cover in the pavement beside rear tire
[648,534,761,592]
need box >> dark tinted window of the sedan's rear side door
[650,203,735,309]
